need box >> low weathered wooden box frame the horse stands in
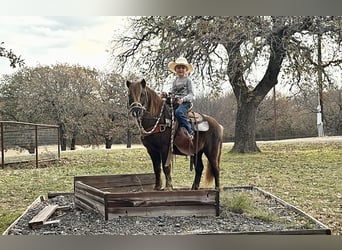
[74,174,219,220]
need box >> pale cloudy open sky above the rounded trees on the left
[0,16,127,76]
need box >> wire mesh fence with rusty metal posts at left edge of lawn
[0,121,60,168]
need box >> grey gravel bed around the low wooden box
[4,189,328,235]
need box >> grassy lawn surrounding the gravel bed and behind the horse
[0,142,342,235]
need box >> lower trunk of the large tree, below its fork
[231,99,260,153]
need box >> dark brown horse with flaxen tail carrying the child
[126,79,223,190]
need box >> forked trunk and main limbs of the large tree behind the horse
[227,19,287,153]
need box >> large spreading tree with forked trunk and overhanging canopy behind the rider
[113,16,341,152]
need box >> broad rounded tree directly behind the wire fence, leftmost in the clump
[0,64,98,150]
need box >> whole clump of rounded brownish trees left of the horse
[0,64,127,150]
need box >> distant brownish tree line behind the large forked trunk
[194,88,342,142]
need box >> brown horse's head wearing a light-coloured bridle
[126,79,148,118]
